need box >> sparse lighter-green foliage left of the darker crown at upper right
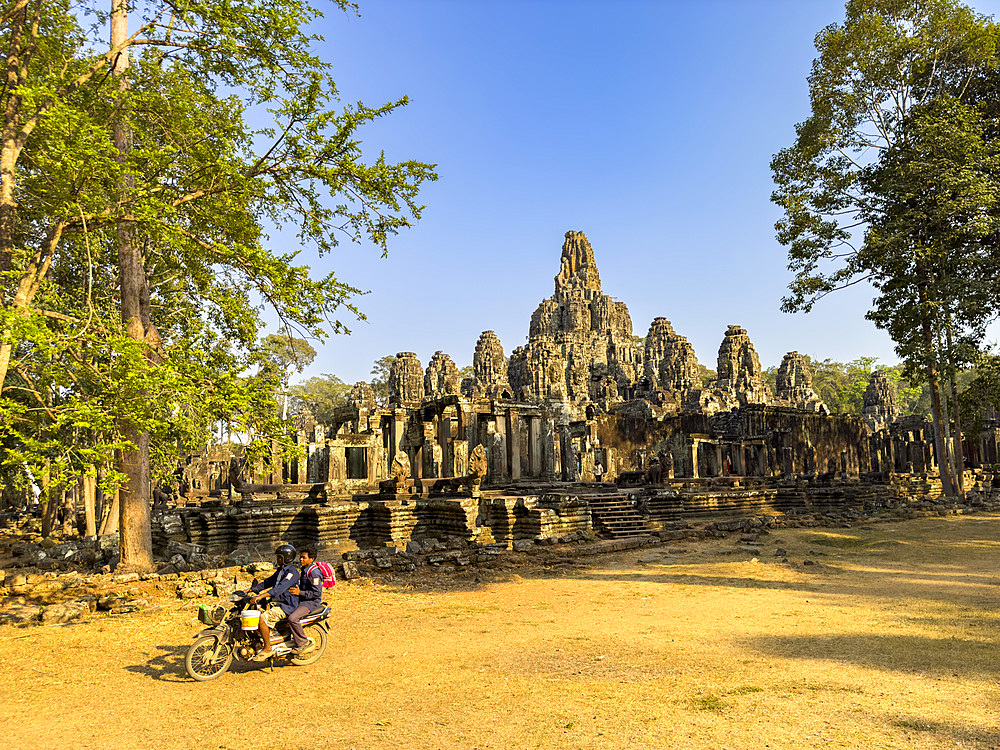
[771,0,996,311]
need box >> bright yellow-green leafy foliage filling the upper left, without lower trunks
[0,0,436,506]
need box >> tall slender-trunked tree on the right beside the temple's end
[771,0,997,494]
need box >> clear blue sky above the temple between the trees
[284,0,1000,382]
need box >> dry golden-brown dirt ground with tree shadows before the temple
[0,515,1000,750]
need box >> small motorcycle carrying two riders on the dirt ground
[184,591,330,682]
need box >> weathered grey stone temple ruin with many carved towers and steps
[164,231,1000,550]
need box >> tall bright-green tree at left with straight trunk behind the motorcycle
[0,0,435,568]
